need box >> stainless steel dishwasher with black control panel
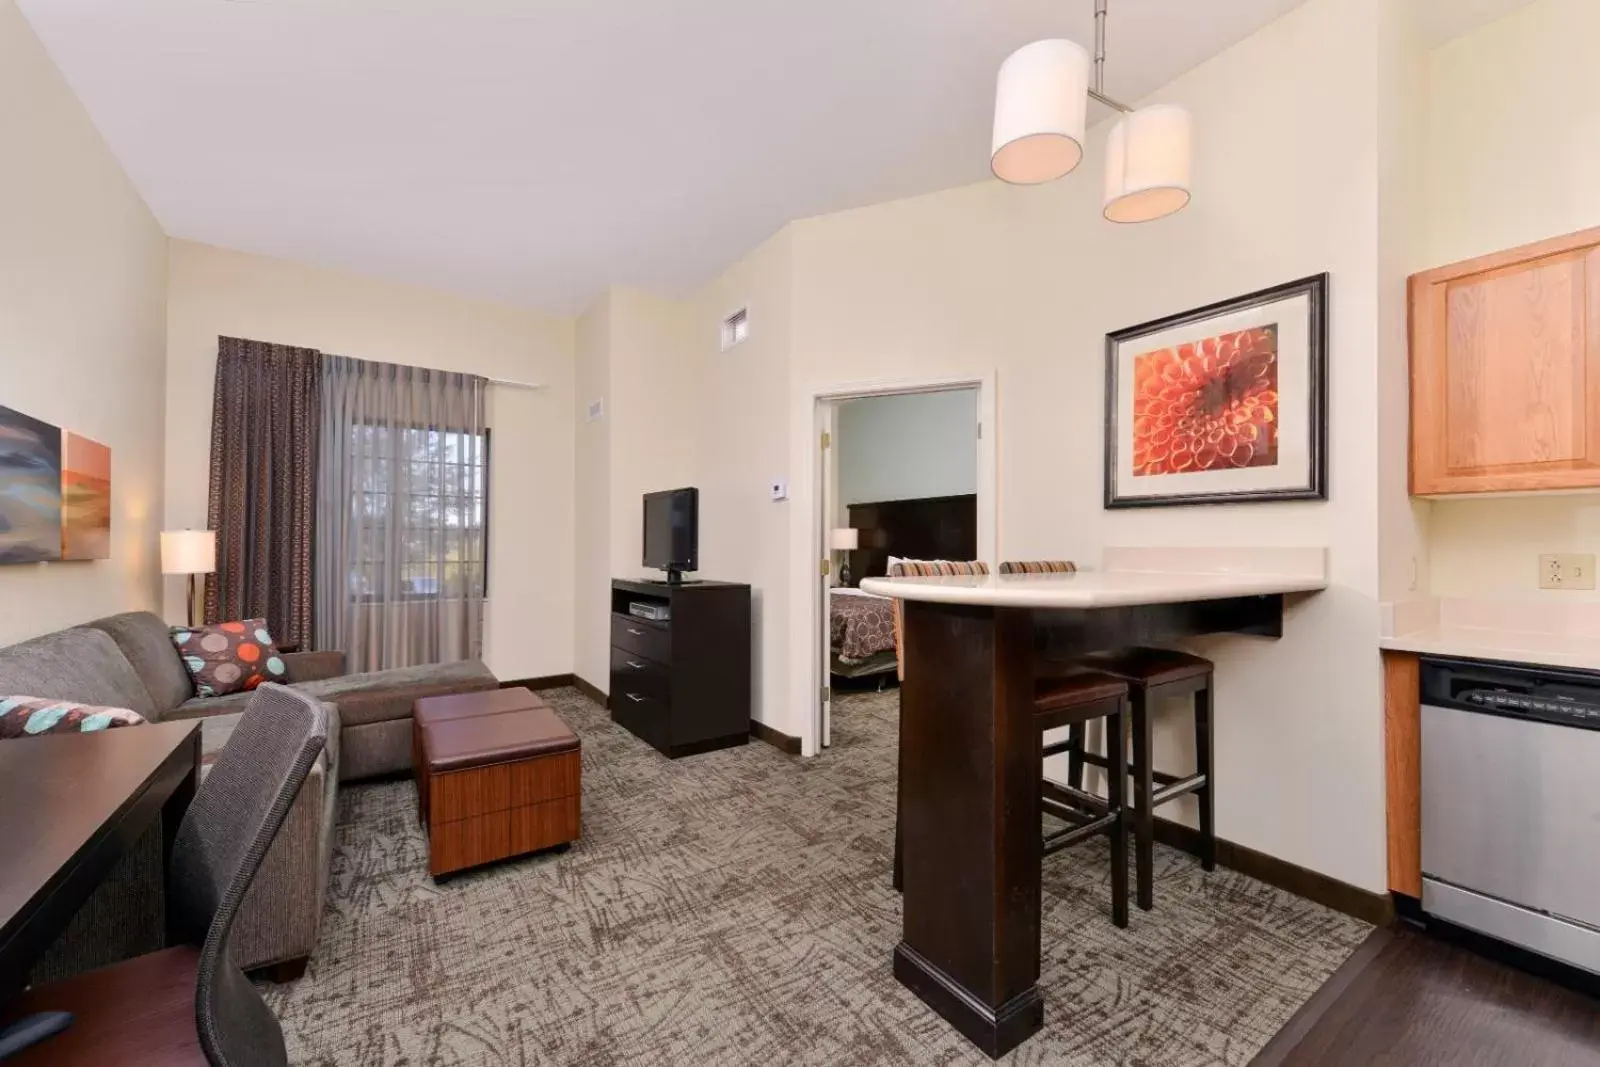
[1422,657,1600,974]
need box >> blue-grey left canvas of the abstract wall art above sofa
[0,408,61,563]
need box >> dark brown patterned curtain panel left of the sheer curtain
[205,338,322,648]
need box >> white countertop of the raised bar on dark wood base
[861,571,1328,608]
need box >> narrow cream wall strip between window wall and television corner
[573,293,613,693]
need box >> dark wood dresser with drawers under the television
[610,579,752,760]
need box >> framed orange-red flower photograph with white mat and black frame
[1106,274,1328,507]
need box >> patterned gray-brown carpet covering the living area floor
[267,689,1368,1067]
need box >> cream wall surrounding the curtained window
[165,240,576,678]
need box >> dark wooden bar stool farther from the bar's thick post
[1064,648,1216,912]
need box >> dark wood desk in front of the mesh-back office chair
[0,720,200,1003]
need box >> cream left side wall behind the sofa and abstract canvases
[0,0,166,645]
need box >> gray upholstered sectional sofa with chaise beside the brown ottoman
[0,611,499,977]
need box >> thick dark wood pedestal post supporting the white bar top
[894,601,1045,1056]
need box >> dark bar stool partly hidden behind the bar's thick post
[1034,670,1130,928]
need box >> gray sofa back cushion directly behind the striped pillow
[0,625,160,721]
